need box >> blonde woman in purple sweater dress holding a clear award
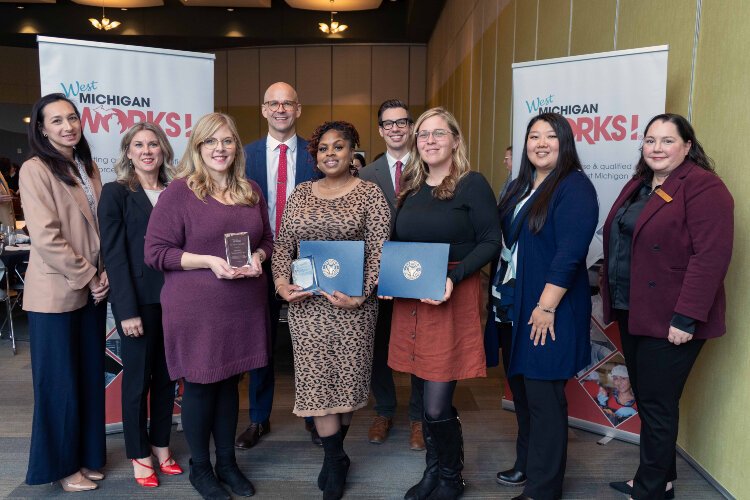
[145,113,273,499]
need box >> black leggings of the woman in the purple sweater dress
[182,375,240,463]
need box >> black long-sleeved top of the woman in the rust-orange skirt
[392,172,502,284]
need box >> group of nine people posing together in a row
[20,78,733,500]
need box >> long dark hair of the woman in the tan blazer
[29,94,94,186]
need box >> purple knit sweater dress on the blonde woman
[145,179,273,384]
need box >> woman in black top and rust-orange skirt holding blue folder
[388,108,501,500]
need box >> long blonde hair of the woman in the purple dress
[176,113,260,206]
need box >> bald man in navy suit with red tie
[235,82,321,449]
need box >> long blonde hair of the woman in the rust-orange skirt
[398,107,471,205]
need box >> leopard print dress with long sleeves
[272,181,390,417]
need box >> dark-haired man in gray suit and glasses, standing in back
[359,99,425,450]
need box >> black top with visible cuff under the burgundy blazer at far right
[607,181,695,333]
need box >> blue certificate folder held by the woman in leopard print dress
[299,241,365,297]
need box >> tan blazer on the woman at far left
[19,157,103,313]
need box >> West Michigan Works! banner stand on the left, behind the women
[37,36,215,432]
